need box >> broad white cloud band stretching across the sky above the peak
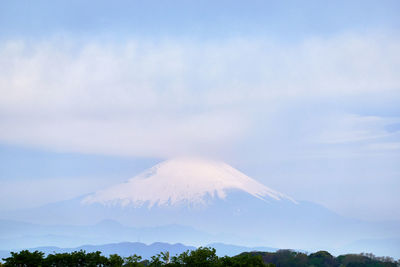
[0,35,400,157]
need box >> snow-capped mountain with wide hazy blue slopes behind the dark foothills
[1,158,400,257]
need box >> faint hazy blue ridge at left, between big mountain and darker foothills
[0,220,218,250]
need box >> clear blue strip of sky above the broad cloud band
[0,0,399,40]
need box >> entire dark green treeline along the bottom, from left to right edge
[0,247,400,267]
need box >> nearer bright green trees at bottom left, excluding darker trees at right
[0,247,268,267]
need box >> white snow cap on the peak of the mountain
[83,158,290,207]
